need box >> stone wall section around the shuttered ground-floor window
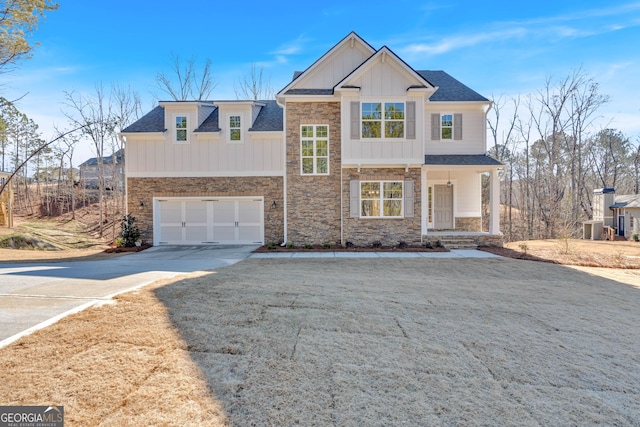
[342,168,422,246]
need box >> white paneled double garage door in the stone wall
[154,198,264,245]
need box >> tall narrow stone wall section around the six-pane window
[286,102,341,246]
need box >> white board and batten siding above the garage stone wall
[126,132,284,177]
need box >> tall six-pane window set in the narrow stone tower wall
[300,125,329,175]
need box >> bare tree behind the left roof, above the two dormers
[156,54,218,101]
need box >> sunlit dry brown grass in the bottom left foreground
[0,274,227,426]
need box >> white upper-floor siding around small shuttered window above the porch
[423,106,487,154]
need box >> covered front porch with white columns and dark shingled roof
[421,155,504,244]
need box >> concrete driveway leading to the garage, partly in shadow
[0,245,257,348]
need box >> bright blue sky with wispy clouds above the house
[0,0,640,164]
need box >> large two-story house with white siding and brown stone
[121,33,502,245]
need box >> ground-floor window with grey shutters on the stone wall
[360,181,404,218]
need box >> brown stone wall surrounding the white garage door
[127,177,284,243]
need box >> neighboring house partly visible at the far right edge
[582,188,640,240]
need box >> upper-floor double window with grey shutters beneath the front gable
[361,102,405,138]
